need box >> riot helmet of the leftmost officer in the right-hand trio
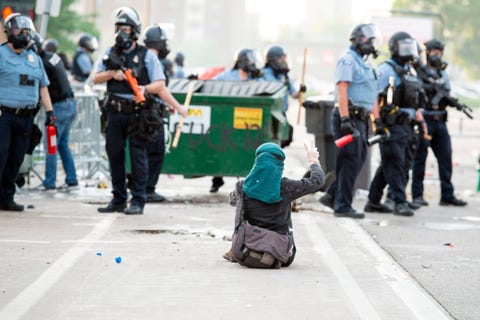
[350,23,381,58]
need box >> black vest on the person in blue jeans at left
[40,51,73,103]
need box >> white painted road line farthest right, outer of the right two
[339,219,452,320]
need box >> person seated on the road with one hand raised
[223,142,324,268]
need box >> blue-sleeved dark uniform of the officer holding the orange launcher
[98,44,164,213]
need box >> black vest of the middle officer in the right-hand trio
[385,61,425,109]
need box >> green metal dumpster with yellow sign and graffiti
[162,79,288,177]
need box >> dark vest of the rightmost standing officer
[418,65,450,110]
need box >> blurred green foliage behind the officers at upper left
[46,0,100,56]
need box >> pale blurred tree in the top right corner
[393,0,480,79]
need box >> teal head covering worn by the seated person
[243,142,285,203]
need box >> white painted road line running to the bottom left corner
[0,215,116,320]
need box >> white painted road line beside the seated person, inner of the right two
[299,215,381,320]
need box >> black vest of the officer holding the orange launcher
[107,44,150,95]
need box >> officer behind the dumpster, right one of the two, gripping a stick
[261,45,307,113]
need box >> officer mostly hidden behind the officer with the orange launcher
[143,25,188,203]
